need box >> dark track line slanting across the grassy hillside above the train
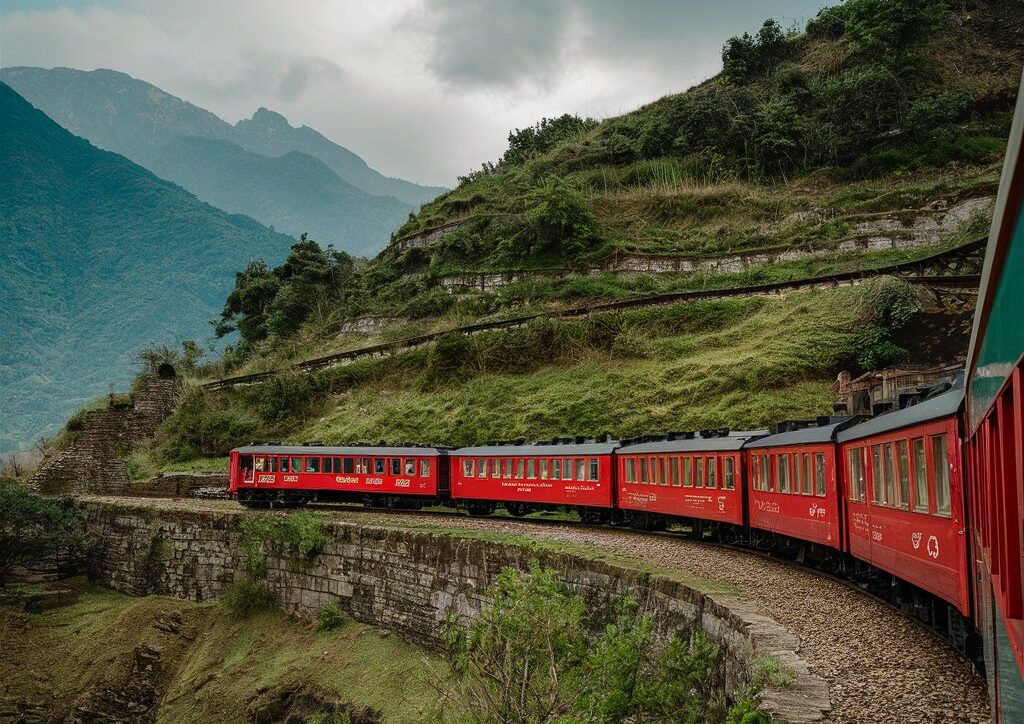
[202,240,985,389]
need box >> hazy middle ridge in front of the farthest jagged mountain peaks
[150,137,410,256]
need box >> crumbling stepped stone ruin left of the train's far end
[29,370,179,495]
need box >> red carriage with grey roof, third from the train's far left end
[615,430,767,533]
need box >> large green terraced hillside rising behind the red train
[58,0,1024,475]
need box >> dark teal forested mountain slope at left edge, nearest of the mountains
[0,84,292,452]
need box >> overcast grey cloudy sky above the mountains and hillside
[0,0,835,185]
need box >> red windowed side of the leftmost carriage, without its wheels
[231,445,444,497]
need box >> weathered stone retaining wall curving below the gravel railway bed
[81,503,829,722]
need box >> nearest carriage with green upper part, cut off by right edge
[967,66,1024,722]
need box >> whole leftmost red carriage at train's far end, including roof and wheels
[228,445,449,507]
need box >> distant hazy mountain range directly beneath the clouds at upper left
[0,67,445,255]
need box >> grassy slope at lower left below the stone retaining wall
[0,590,446,724]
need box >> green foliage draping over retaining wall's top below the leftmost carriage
[239,511,328,579]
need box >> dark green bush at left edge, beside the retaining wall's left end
[0,478,86,581]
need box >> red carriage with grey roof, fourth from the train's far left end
[743,418,855,553]
